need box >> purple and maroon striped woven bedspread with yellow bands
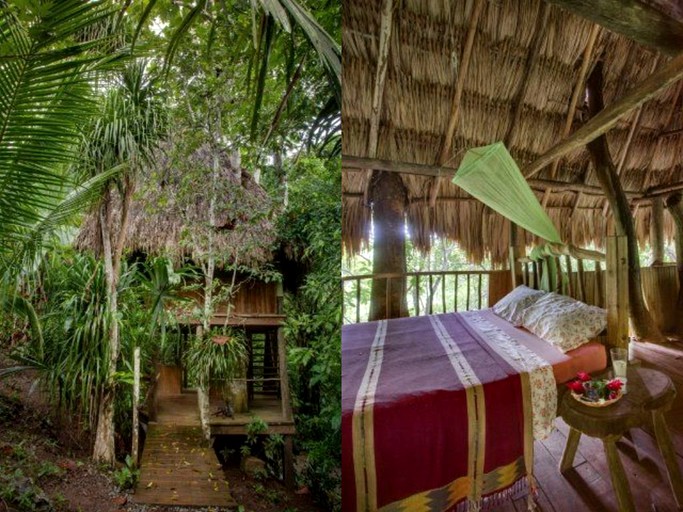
[342,312,557,512]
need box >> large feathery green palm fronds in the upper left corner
[0,0,123,270]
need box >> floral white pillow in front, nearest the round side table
[522,293,607,352]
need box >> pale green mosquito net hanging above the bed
[453,142,562,243]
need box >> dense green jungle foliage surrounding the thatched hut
[0,0,341,509]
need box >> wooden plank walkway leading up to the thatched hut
[134,392,237,507]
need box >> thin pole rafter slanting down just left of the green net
[429,0,485,206]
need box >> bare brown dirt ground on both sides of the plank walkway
[0,360,322,512]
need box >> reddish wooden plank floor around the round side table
[496,342,683,512]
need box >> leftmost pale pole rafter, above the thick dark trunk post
[365,0,394,203]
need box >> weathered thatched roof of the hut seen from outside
[75,145,276,268]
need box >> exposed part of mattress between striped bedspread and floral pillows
[480,309,607,384]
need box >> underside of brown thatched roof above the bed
[342,0,683,263]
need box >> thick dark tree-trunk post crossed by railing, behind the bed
[370,171,408,320]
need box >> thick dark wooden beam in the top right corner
[547,0,683,57]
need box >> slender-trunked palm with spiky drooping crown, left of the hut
[81,60,164,464]
